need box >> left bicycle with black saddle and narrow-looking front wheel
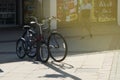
[16,16,49,62]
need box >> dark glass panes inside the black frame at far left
[0,0,16,25]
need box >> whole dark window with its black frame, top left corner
[0,0,23,27]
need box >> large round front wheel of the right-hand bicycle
[48,33,68,62]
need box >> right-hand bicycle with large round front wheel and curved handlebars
[43,16,68,62]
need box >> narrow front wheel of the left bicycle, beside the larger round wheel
[37,44,49,63]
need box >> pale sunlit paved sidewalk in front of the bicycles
[0,50,120,80]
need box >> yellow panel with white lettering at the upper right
[94,0,117,22]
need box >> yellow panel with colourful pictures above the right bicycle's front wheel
[57,0,78,22]
